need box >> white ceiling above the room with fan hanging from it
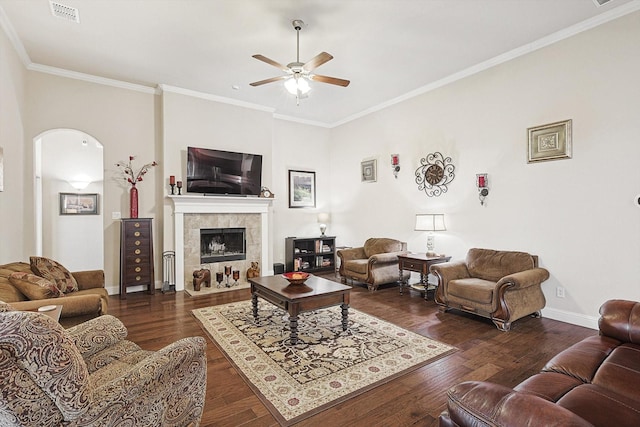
[0,0,640,126]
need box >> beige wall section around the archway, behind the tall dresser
[25,71,162,293]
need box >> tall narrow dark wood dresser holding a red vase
[120,218,155,299]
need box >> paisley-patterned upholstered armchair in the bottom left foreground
[0,304,207,427]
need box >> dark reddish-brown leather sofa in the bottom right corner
[440,300,640,427]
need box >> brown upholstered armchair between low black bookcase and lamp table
[338,237,411,291]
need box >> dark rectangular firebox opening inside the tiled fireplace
[200,228,247,264]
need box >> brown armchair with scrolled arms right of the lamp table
[430,248,549,331]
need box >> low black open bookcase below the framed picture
[285,236,336,273]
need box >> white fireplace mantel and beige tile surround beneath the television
[167,195,273,291]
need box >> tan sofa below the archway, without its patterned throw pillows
[0,262,109,327]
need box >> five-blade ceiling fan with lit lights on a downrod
[250,19,350,99]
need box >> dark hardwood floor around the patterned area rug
[109,274,597,426]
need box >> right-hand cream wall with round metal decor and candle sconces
[331,13,640,327]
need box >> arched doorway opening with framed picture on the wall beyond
[34,129,104,271]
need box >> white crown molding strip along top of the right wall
[329,0,640,128]
